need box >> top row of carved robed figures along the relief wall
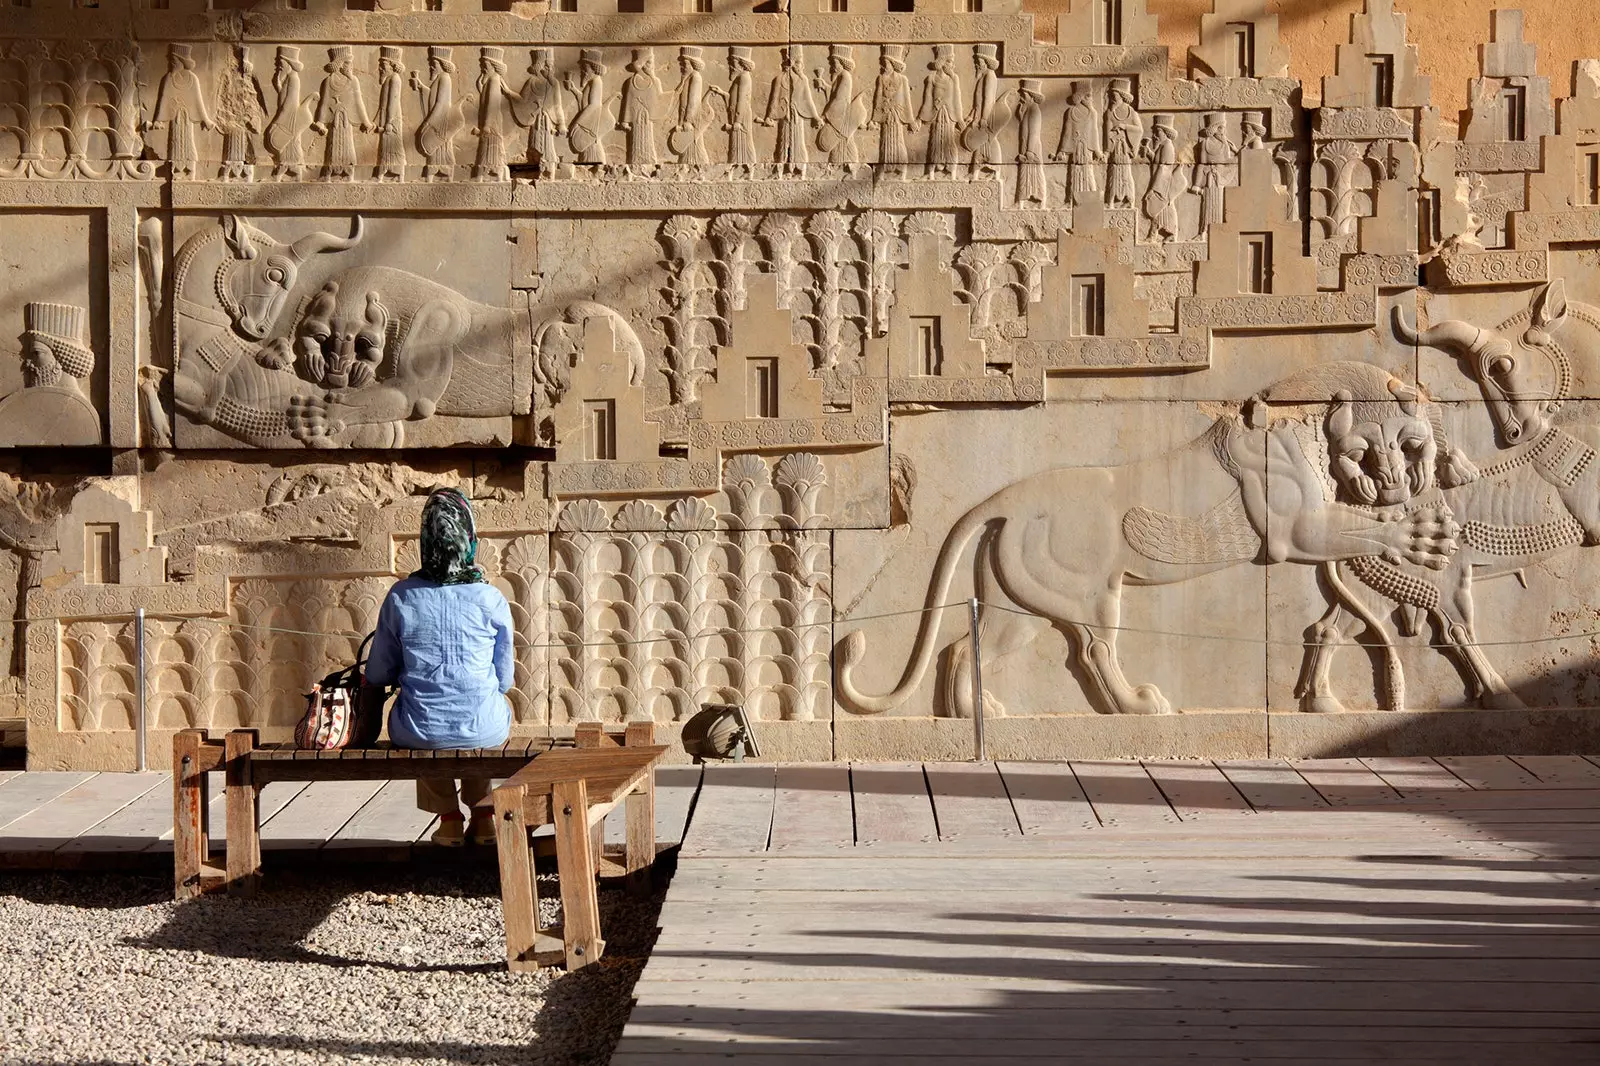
[0,40,1294,228]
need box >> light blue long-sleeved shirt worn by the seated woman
[366,578,515,747]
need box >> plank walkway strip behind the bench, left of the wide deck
[0,767,701,872]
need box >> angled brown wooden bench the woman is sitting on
[173,722,666,970]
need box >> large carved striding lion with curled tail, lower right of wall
[835,362,1461,717]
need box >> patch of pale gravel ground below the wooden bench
[0,868,661,1066]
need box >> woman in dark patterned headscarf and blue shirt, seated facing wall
[366,488,515,847]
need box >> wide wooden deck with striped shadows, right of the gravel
[611,755,1600,1066]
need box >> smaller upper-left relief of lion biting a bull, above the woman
[173,216,643,448]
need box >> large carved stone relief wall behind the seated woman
[9,0,1600,767]
